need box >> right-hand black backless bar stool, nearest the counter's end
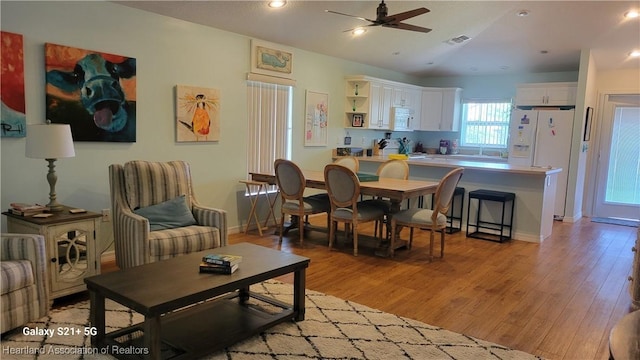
[467,189,516,242]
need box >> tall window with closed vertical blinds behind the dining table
[247,81,293,184]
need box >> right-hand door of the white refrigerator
[533,110,575,218]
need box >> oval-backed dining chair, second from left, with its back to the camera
[324,164,384,256]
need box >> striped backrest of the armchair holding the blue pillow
[123,160,193,210]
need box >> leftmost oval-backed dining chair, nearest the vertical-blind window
[274,159,330,244]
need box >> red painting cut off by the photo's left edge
[0,31,26,137]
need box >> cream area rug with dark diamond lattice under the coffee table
[0,281,540,360]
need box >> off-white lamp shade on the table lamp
[26,124,76,159]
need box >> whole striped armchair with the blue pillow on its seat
[109,160,227,269]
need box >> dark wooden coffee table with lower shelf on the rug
[85,243,310,359]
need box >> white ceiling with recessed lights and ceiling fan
[115,0,640,76]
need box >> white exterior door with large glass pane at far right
[593,94,640,219]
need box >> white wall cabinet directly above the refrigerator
[516,82,577,106]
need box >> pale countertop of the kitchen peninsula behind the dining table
[358,154,562,175]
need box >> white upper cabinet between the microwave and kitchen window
[418,88,462,131]
